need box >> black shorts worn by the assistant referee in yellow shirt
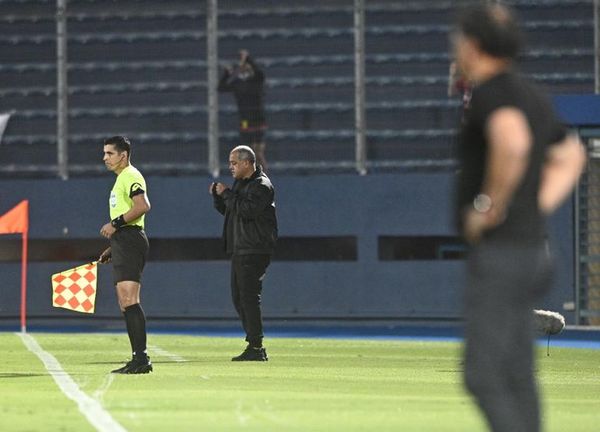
[110,226,149,285]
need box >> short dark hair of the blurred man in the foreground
[457,3,523,60]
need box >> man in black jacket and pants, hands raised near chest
[210,146,277,361]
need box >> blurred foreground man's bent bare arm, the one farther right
[538,135,586,214]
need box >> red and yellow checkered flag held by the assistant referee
[52,261,98,313]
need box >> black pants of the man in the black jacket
[231,255,271,347]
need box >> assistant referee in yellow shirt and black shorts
[99,136,152,374]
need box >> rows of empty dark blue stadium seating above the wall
[0,0,594,175]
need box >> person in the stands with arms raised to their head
[219,50,267,172]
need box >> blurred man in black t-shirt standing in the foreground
[452,3,585,432]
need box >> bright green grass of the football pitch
[0,333,600,432]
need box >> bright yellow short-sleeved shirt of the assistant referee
[108,165,147,228]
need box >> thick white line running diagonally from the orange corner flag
[16,333,127,432]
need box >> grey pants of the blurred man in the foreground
[464,240,552,432]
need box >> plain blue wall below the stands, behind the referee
[0,173,573,319]
